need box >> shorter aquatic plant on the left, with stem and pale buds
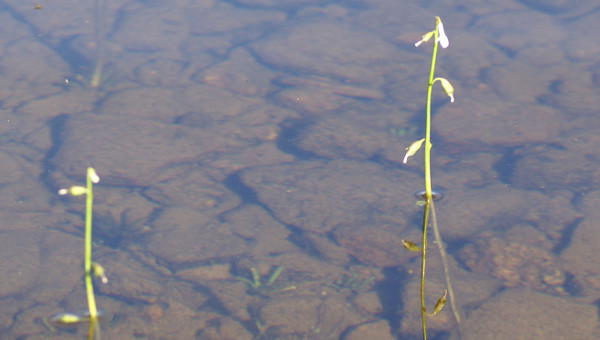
[49,167,108,340]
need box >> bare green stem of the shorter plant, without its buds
[83,168,98,330]
